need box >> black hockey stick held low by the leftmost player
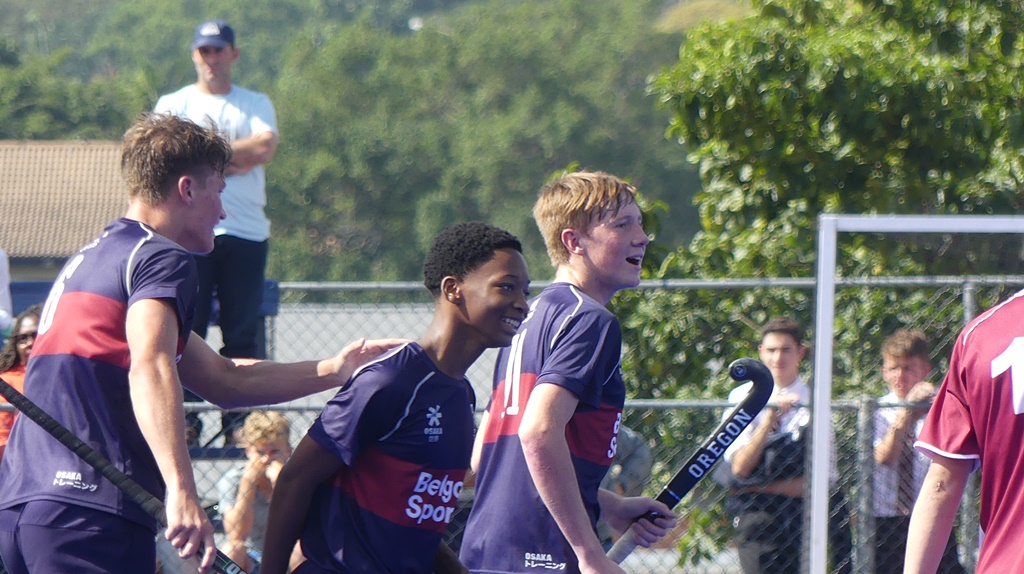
[0,379,246,574]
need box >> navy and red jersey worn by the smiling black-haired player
[294,343,475,574]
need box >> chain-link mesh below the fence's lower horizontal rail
[182,398,950,574]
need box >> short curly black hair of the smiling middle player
[423,221,522,298]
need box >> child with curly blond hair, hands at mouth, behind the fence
[217,410,301,574]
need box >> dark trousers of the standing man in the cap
[183,235,269,444]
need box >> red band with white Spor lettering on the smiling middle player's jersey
[334,448,466,532]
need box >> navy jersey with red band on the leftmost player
[0,218,197,530]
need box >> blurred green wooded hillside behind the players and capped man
[0,0,697,280]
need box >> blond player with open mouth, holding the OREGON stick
[461,172,675,573]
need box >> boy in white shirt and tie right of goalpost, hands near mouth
[873,329,964,574]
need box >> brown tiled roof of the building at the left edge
[0,140,128,259]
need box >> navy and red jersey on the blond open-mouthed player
[461,283,626,572]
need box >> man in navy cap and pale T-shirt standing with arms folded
[155,19,278,446]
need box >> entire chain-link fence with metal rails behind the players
[169,277,1024,573]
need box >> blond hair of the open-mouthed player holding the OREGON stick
[534,172,637,267]
